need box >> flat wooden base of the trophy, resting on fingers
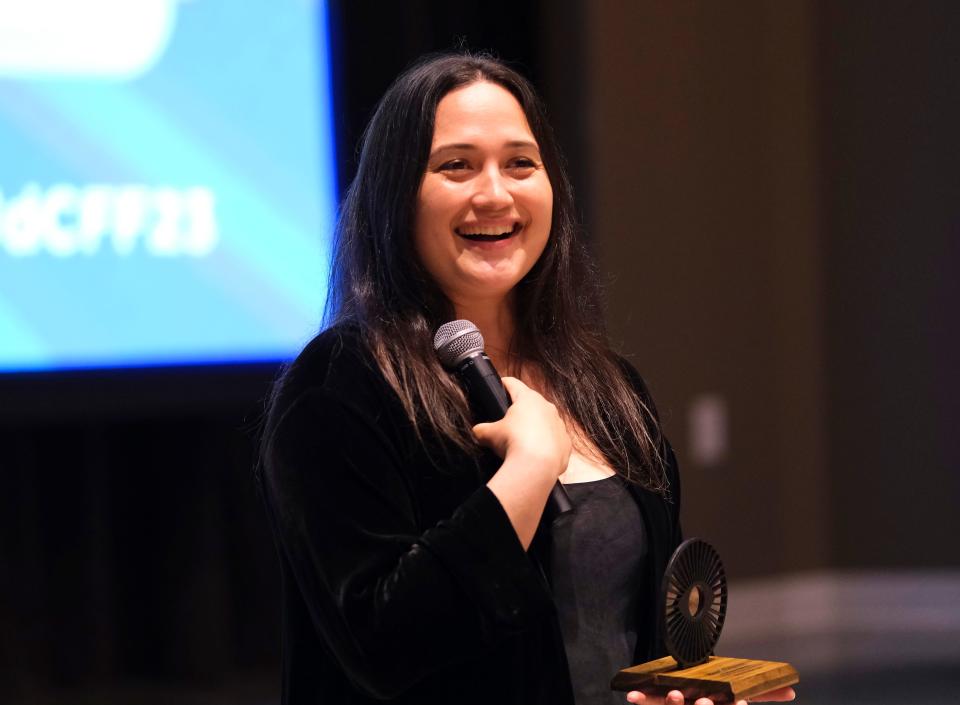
[610,656,800,703]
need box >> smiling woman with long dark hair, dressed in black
[260,54,796,705]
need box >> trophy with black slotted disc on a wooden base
[610,538,800,704]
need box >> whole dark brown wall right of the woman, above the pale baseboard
[584,1,960,577]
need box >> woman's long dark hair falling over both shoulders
[325,53,665,491]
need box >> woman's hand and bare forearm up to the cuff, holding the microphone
[473,377,572,550]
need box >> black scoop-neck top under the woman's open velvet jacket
[550,475,647,705]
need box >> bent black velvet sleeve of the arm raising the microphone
[263,386,553,698]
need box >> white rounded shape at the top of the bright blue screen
[0,0,179,79]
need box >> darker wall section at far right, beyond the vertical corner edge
[818,0,960,567]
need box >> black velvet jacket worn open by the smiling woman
[262,327,680,705]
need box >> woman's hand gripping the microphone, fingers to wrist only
[473,377,571,480]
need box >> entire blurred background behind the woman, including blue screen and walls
[0,0,960,704]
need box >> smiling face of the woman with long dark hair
[414,81,553,305]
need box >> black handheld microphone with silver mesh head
[433,320,573,519]
